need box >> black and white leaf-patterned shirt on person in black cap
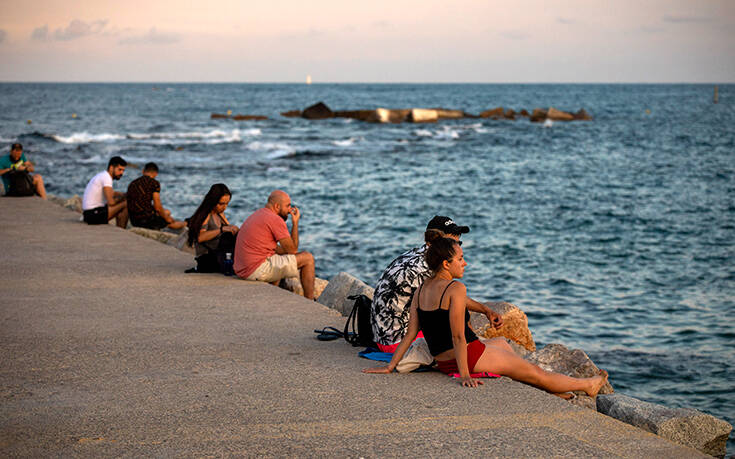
[371,244,431,346]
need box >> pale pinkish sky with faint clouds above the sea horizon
[0,0,735,83]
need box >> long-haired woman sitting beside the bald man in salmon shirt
[187,183,239,272]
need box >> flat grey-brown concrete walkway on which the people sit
[0,198,706,458]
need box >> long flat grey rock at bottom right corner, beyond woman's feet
[597,394,732,457]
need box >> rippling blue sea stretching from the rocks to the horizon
[0,83,735,454]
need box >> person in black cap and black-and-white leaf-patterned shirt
[370,215,503,353]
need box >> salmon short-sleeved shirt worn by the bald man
[234,207,291,279]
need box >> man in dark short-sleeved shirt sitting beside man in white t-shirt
[127,163,186,230]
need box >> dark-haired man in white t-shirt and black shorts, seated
[82,156,128,228]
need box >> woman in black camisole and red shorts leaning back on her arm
[363,239,607,397]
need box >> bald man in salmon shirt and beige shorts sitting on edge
[234,190,314,300]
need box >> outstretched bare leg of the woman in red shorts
[473,343,607,397]
